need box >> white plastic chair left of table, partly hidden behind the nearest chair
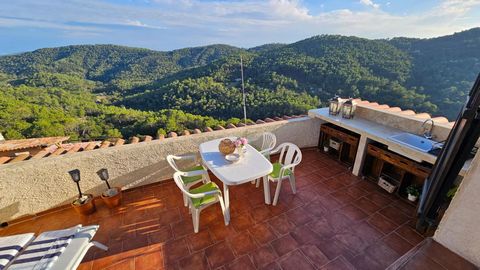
[167,155,210,206]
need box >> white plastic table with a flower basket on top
[200,138,273,222]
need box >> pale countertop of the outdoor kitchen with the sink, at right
[308,108,470,176]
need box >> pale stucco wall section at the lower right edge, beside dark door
[434,154,480,266]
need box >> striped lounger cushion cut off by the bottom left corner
[0,233,34,270]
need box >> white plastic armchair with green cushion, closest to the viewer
[173,171,228,233]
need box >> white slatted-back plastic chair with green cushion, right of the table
[267,143,302,205]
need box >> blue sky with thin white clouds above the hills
[0,0,480,54]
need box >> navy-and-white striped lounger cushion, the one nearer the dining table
[9,225,81,269]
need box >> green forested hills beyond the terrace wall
[0,28,480,140]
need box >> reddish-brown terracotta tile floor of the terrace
[0,149,423,270]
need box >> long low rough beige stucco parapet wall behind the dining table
[0,117,320,222]
